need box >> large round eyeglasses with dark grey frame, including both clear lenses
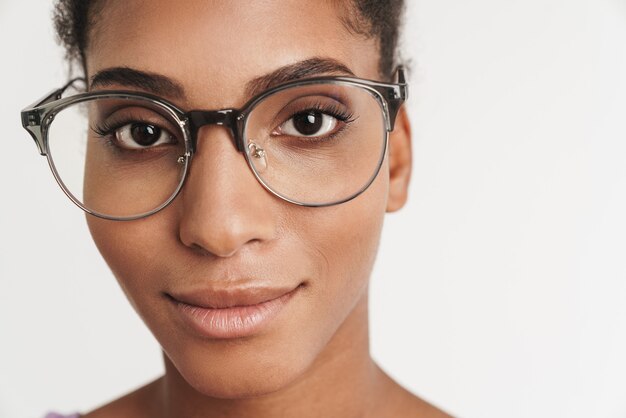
[21,69,408,220]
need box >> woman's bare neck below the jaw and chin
[154,292,385,418]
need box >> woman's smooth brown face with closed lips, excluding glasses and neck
[87,0,408,397]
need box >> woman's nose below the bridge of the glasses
[174,126,276,257]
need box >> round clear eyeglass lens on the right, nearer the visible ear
[244,84,386,205]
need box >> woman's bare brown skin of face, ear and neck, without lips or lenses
[78,0,449,418]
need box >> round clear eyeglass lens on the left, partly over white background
[48,98,185,218]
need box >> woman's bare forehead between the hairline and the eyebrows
[87,0,379,107]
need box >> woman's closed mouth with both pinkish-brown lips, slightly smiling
[165,284,304,339]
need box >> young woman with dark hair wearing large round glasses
[22,0,448,418]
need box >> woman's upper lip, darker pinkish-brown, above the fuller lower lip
[167,286,299,309]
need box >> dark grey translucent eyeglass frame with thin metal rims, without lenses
[21,67,409,221]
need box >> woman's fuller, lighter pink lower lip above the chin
[172,287,299,339]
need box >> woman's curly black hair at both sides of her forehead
[53,0,404,79]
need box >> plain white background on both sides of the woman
[0,0,626,418]
